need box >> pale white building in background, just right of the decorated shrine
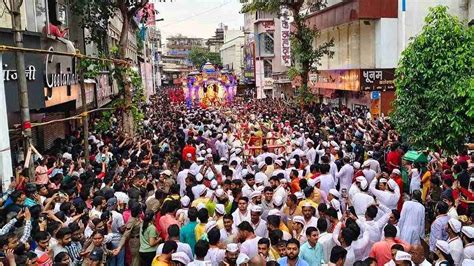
[220,27,245,80]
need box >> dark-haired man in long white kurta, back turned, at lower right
[398,190,425,245]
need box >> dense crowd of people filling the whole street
[0,93,474,266]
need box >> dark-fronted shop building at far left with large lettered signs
[0,0,82,156]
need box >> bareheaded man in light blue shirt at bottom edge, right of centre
[299,226,324,266]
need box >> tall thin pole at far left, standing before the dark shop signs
[8,0,35,179]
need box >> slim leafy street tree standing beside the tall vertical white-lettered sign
[242,0,334,102]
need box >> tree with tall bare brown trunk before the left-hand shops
[71,0,149,135]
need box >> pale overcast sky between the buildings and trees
[152,0,244,39]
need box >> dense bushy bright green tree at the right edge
[391,6,474,153]
